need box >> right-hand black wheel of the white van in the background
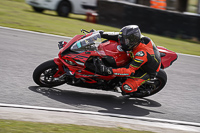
[57,1,71,17]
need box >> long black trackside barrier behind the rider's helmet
[98,0,200,40]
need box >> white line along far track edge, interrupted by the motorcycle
[0,26,200,58]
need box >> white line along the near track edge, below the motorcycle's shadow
[0,103,200,127]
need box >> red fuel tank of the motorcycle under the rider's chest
[100,40,131,67]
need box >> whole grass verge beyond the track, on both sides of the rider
[0,0,200,55]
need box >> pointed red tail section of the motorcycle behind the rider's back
[157,46,178,69]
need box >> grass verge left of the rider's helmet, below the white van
[0,0,118,37]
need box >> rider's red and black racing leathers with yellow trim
[112,37,161,93]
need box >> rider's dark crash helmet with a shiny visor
[118,25,141,51]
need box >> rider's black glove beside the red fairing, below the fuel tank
[96,58,113,76]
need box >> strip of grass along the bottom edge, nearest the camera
[0,120,152,133]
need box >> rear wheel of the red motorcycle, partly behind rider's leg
[131,69,167,98]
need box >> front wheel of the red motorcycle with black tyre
[33,60,66,87]
